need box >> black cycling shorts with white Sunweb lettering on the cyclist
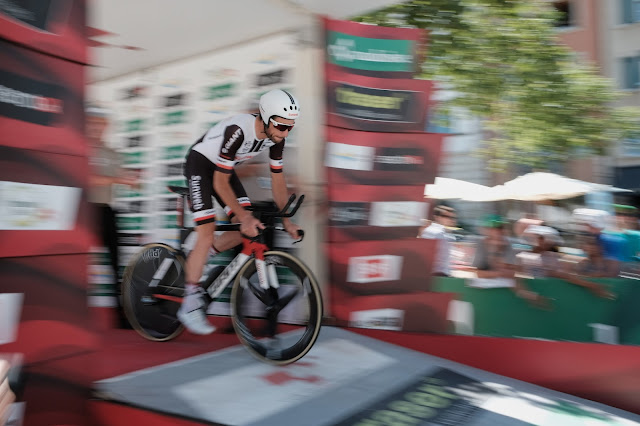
[184,151,251,226]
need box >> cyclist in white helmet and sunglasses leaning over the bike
[178,89,300,334]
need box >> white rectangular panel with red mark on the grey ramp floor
[171,339,396,425]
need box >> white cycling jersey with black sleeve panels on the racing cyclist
[191,114,285,173]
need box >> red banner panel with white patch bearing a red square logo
[328,238,437,294]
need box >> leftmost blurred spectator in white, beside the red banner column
[418,205,458,277]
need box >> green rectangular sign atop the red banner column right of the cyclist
[327,31,415,72]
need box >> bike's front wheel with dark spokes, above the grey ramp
[231,251,323,365]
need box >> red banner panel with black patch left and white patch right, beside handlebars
[328,185,429,242]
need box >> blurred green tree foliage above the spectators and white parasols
[354,0,640,170]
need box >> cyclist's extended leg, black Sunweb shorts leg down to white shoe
[178,151,216,334]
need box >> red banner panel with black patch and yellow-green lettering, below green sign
[327,66,433,133]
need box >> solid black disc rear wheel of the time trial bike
[122,243,184,342]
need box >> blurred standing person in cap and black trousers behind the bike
[85,104,137,328]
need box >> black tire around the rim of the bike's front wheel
[230,250,324,365]
